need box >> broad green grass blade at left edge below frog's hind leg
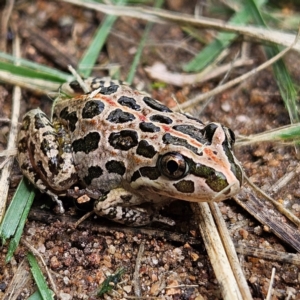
[0,179,32,244]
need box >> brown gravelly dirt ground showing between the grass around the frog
[0,1,300,300]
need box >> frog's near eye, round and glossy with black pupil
[157,152,188,179]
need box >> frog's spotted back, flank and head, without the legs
[53,79,242,201]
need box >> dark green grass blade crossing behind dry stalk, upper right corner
[248,0,299,123]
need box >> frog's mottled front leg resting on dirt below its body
[94,188,174,226]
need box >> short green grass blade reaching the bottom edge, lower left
[27,252,54,300]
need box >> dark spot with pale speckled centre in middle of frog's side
[108,130,138,151]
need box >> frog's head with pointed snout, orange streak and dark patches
[131,123,243,202]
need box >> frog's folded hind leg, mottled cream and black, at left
[17,109,78,211]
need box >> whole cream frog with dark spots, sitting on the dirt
[18,78,242,226]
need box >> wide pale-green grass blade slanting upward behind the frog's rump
[77,0,126,78]
